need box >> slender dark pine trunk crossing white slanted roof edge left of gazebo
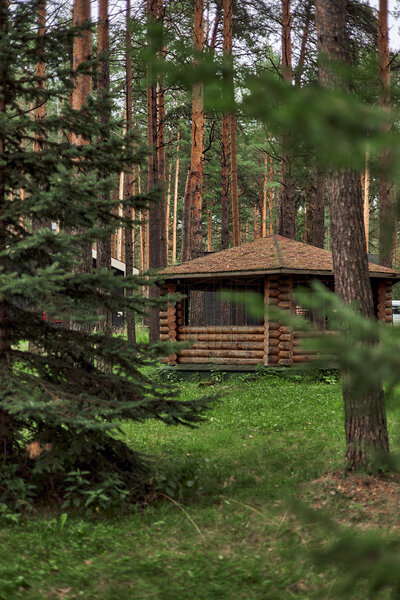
[124,0,136,342]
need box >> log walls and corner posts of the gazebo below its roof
[160,275,376,366]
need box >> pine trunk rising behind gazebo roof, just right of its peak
[278,0,296,240]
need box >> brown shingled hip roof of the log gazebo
[160,235,400,280]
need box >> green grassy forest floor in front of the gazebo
[0,374,400,600]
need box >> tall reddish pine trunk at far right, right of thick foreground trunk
[378,0,394,267]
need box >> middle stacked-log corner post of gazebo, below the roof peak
[264,275,293,367]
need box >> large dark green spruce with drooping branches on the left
[0,0,208,506]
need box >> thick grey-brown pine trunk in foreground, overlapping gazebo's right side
[316,0,389,469]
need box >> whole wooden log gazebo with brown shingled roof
[160,235,400,368]
